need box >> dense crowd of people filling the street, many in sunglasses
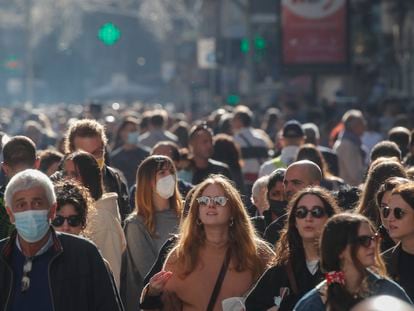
[0,101,414,311]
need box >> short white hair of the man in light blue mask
[4,169,56,208]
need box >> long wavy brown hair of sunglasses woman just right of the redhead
[274,186,340,267]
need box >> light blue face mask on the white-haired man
[14,210,50,243]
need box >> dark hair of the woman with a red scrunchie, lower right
[320,213,386,311]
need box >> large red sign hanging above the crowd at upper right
[281,0,348,65]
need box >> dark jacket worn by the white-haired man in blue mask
[0,229,123,311]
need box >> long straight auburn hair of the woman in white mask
[135,155,183,236]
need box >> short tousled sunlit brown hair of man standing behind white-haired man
[64,119,108,153]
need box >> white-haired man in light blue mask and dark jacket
[0,169,123,311]
